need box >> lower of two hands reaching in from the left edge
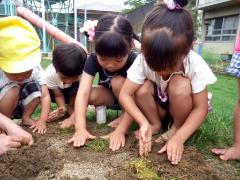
[0,133,21,154]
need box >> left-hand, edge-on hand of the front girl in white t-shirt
[139,122,152,156]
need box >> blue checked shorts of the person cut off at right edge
[226,51,240,78]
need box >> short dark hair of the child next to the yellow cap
[52,43,87,77]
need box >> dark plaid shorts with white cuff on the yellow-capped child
[13,81,41,119]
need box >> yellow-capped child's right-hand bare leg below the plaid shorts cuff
[22,97,40,126]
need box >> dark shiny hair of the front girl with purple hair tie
[141,0,194,71]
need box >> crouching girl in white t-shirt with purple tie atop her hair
[120,0,216,164]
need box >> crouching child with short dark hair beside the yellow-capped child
[45,43,87,128]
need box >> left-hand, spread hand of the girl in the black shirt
[68,129,96,147]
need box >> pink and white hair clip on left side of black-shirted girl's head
[80,20,98,42]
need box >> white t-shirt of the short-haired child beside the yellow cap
[45,64,72,89]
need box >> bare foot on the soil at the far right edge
[212,146,240,161]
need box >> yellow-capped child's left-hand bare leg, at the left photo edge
[0,86,20,118]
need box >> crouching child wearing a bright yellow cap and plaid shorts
[0,17,50,134]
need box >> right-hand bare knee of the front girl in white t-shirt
[168,75,192,98]
